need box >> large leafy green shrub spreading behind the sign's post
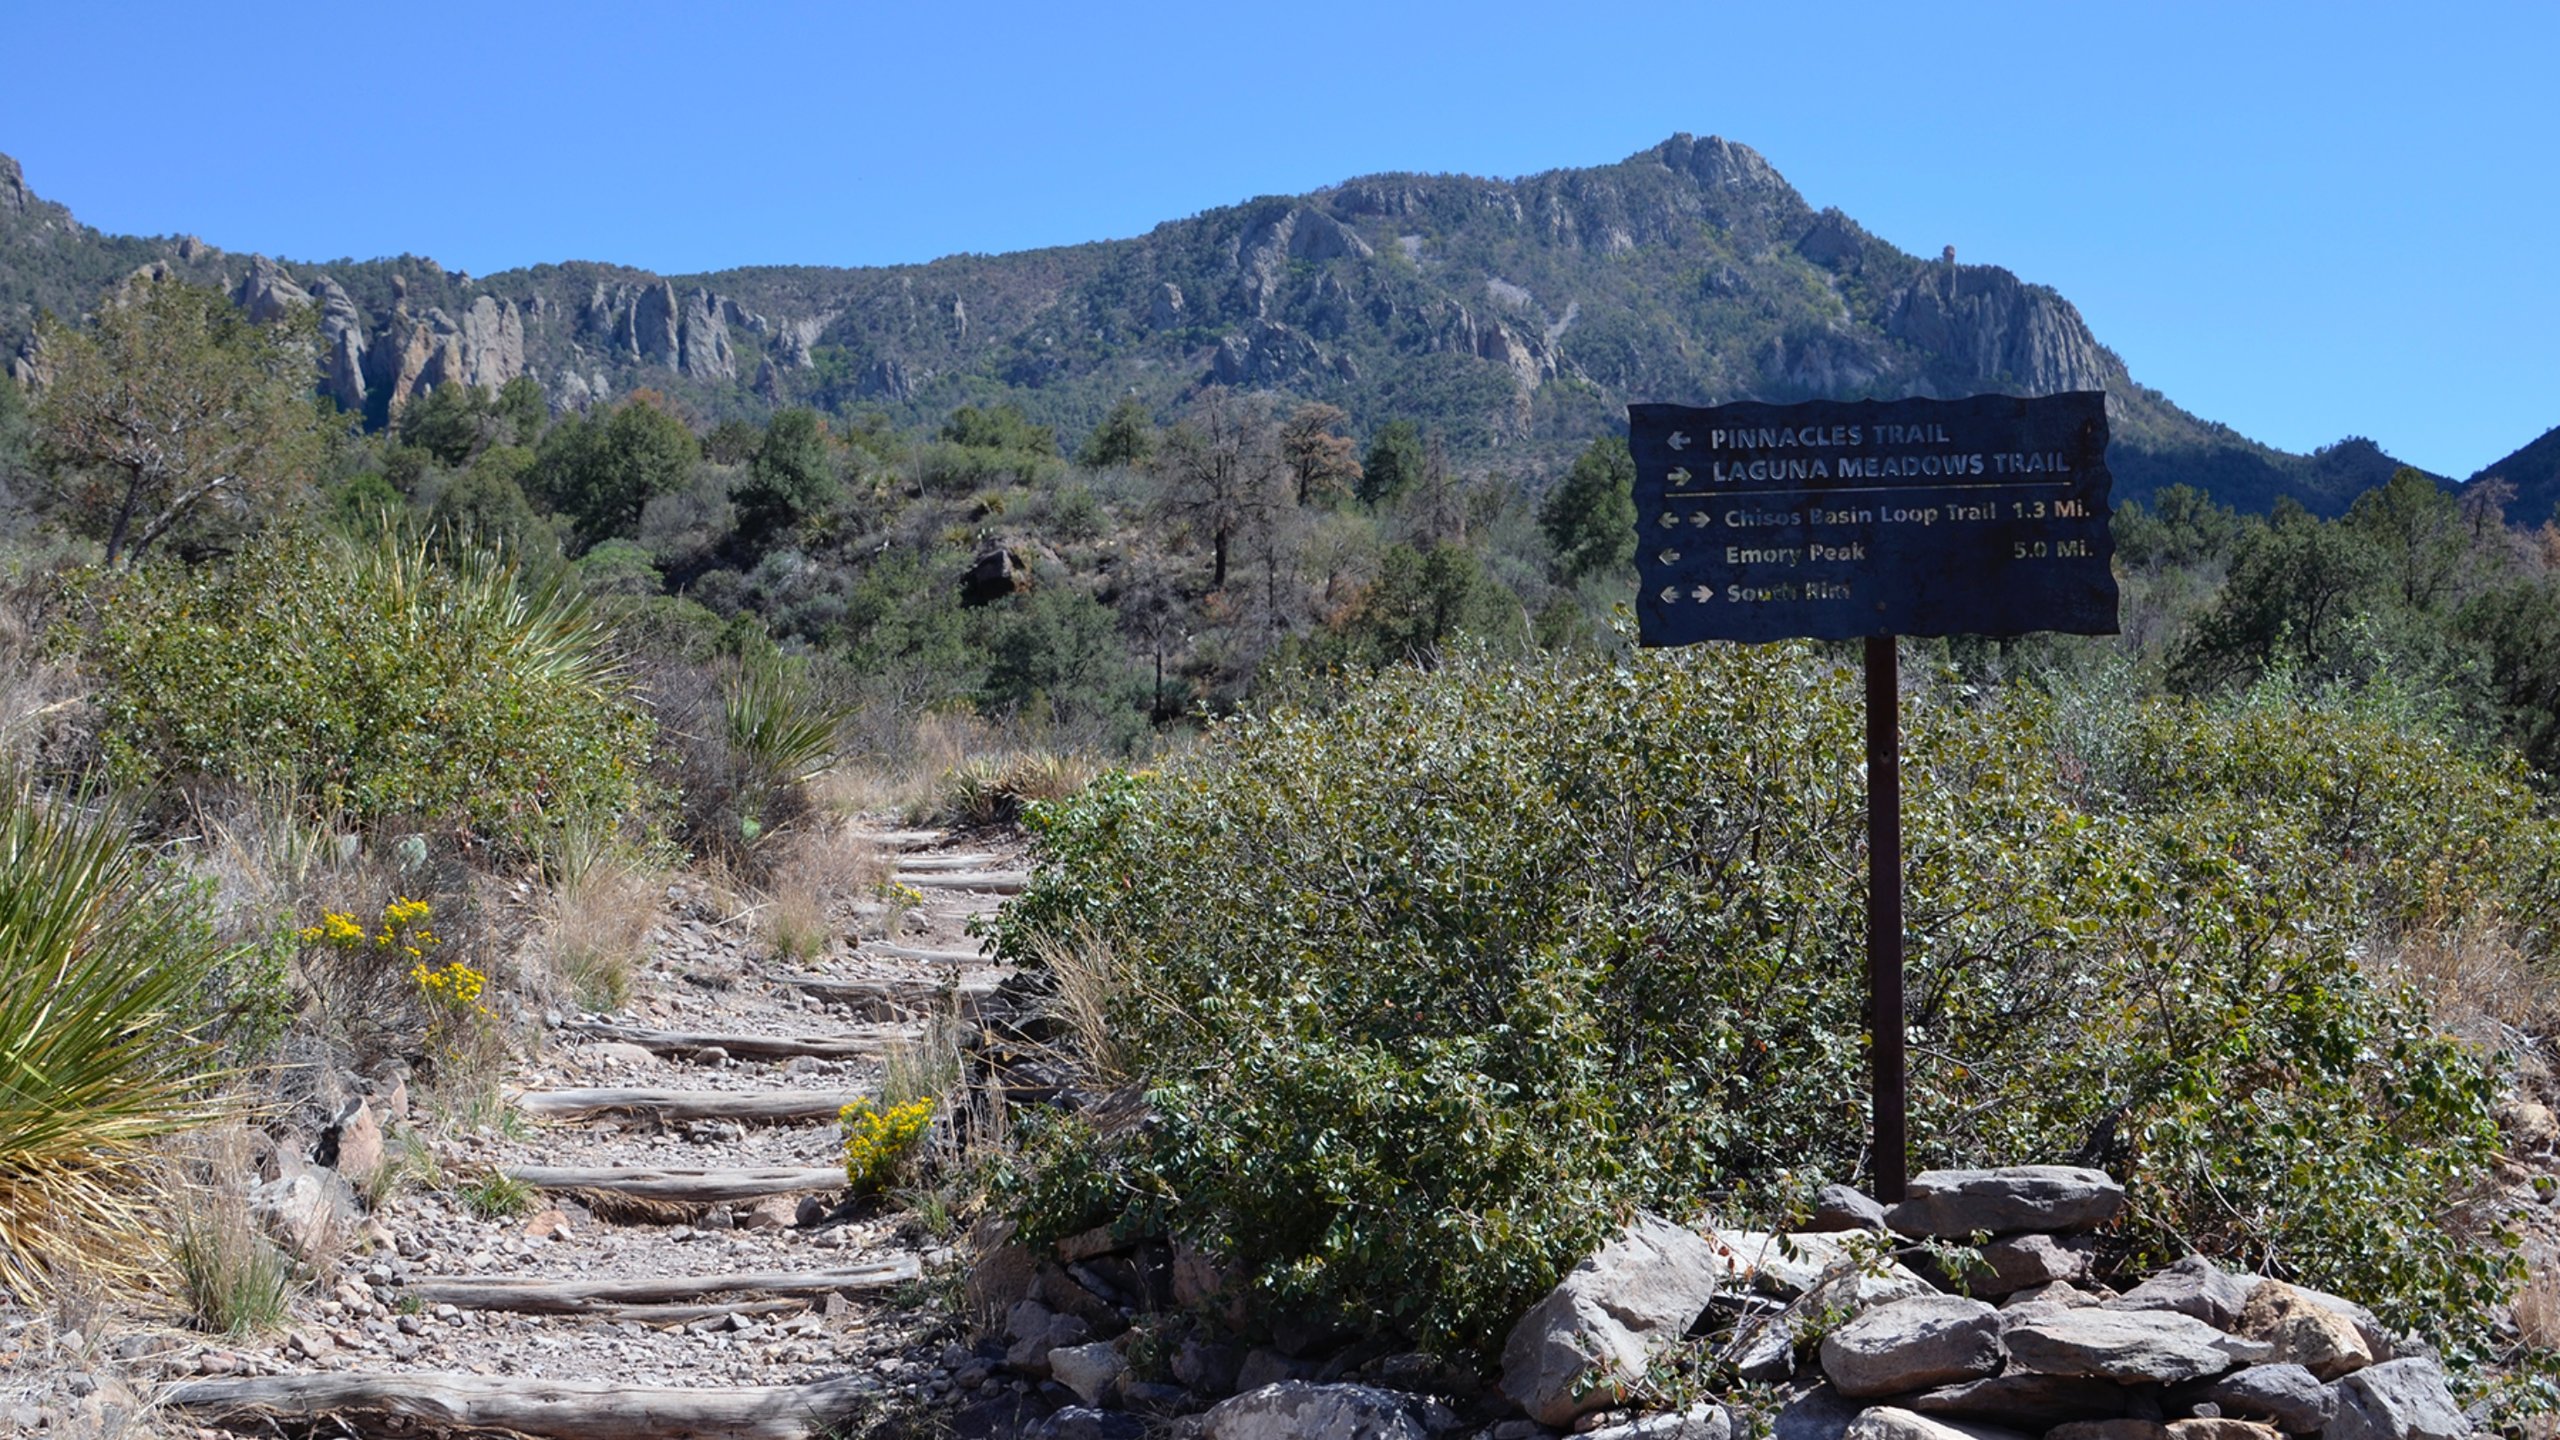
[998,646,2550,1353]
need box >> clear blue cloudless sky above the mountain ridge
[0,0,2560,477]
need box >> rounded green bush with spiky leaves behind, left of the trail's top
[82,533,648,846]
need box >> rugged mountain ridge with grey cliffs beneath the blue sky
[0,136,2457,515]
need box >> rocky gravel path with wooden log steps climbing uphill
[156,830,1021,1440]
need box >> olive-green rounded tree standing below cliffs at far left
[36,279,325,564]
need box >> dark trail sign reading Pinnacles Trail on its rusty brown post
[1628,392,2117,1202]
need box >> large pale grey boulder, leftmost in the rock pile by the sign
[1503,1215,1720,1427]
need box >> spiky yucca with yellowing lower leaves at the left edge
[0,784,230,1297]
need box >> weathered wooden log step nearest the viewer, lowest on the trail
[161,1373,878,1440]
